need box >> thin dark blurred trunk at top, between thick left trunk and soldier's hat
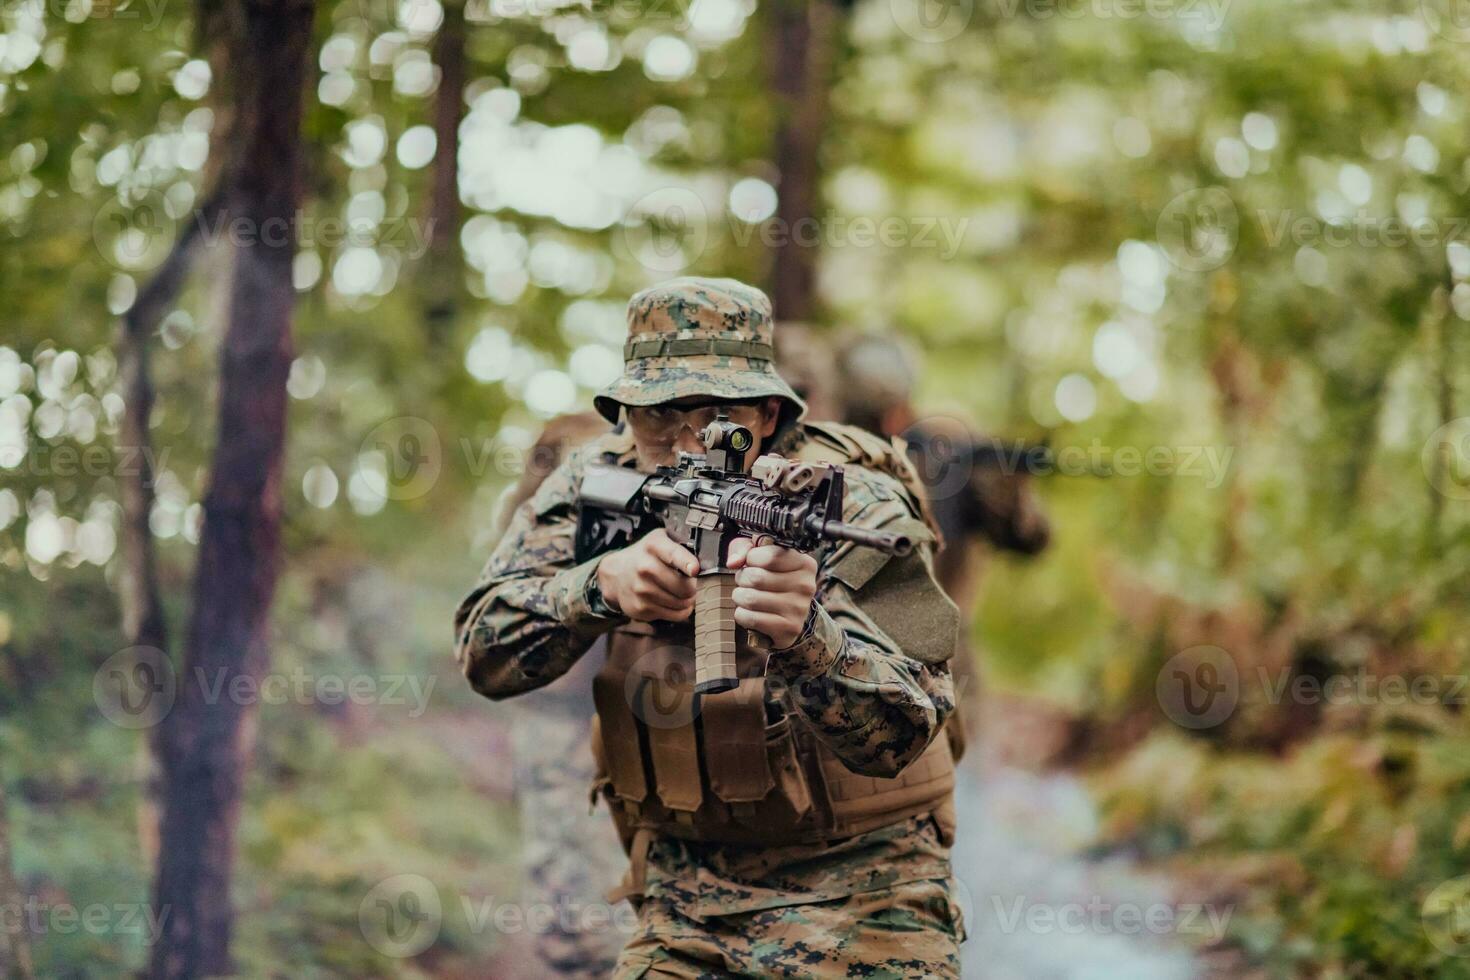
[423,1,466,344]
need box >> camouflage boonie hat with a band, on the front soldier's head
[592,276,807,425]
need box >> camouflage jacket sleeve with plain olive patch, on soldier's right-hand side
[769,467,958,776]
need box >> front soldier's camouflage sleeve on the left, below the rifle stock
[454,444,626,699]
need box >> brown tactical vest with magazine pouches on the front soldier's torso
[592,423,954,862]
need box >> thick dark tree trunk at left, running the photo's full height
[150,0,315,979]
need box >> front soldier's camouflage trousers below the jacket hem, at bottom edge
[613,880,964,980]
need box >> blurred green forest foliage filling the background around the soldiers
[0,0,1470,977]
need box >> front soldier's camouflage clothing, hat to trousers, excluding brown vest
[456,279,963,977]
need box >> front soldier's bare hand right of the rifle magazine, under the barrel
[726,538,817,649]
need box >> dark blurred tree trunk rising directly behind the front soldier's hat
[767,0,841,320]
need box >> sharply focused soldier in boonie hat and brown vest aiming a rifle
[454,279,963,977]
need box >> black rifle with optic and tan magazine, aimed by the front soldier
[576,413,913,693]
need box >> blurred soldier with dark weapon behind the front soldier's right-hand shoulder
[838,335,1051,749]
